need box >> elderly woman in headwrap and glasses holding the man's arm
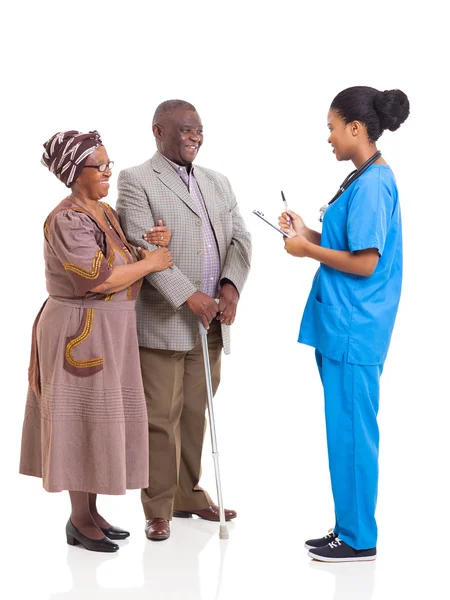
[20,131,173,552]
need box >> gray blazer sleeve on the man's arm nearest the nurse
[220,177,252,295]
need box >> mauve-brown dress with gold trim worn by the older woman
[20,198,148,494]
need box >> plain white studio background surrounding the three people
[0,0,450,600]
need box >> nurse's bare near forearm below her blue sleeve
[306,243,379,277]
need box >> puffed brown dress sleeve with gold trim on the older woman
[49,210,112,296]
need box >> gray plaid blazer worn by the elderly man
[116,152,251,354]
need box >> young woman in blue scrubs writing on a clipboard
[279,86,409,562]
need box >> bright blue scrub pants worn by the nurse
[316,350,383,550]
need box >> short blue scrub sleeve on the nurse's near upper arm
[347,177,394,256]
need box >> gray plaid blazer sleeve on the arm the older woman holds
[116,171,197,310]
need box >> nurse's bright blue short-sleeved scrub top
[298,164,402,365]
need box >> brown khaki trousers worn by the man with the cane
[139,320,222,519]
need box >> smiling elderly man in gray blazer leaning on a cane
[117,100,251,540]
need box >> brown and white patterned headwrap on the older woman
[41,130,103,187]
